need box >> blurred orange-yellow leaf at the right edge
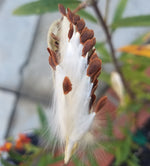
[118,45,150,58]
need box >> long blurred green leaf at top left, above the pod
[13,0,80,15]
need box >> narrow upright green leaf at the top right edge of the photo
[113,0,128,22]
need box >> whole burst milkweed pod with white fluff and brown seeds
[47,5,106,163]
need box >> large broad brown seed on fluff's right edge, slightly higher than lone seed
[87,59,101,77]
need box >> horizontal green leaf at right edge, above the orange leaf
[111,15,150,28]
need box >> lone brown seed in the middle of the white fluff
[63,76,72,95]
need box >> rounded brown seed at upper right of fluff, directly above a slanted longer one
[80,28,94,44]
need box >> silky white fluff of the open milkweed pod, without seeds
[48,7,102,163]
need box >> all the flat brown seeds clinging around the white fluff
[48,4,106,110]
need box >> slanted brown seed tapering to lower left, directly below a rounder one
[82,38,96,57]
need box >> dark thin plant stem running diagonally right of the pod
[92,0,135,100]
